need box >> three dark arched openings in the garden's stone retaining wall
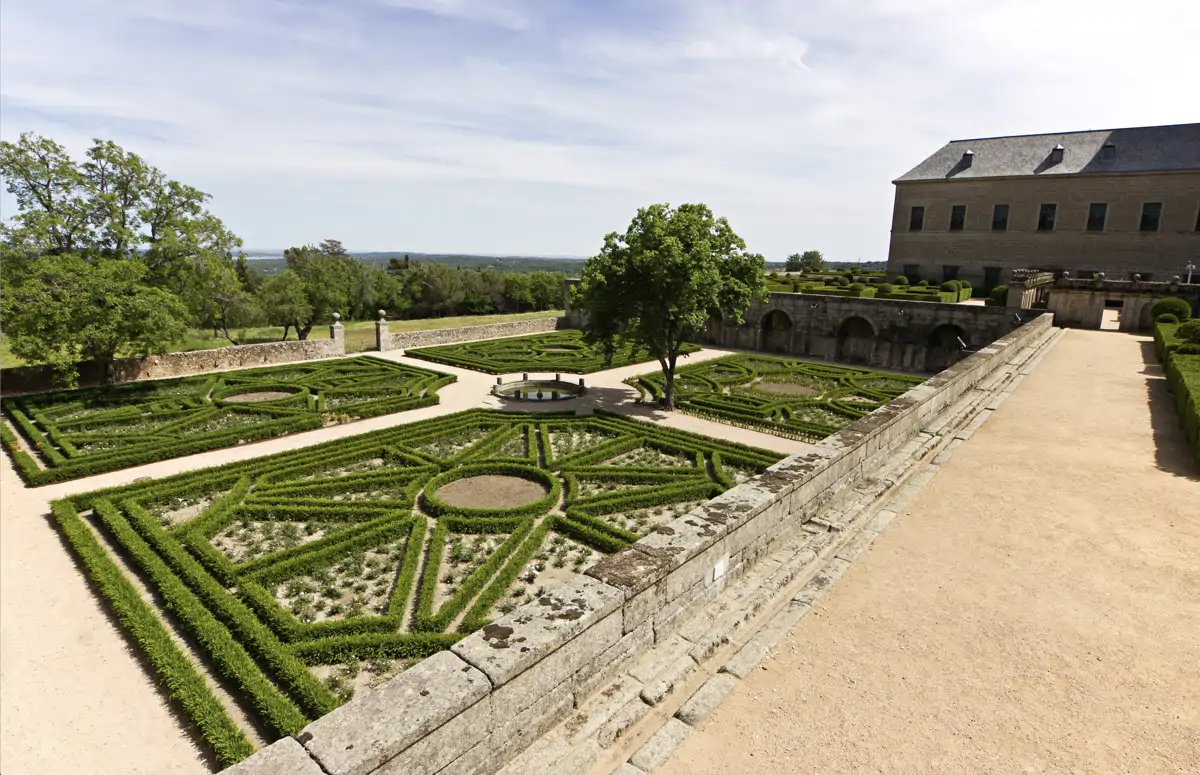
[760,310,967,372]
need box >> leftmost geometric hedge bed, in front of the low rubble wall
[0,356,455,485]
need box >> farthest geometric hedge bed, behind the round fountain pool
[404,330,700,374]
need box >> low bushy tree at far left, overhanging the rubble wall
[0,253,188,386]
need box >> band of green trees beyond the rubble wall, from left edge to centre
[0,133,565,384]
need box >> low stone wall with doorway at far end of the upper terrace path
[1046,277,1200,331]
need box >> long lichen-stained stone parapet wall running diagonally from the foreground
[232,316,1052,775]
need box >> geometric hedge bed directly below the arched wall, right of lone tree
[626,355,924,440]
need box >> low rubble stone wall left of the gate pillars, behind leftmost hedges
[0,338,346,396]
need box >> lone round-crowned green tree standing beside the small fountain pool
[578,204,767,409]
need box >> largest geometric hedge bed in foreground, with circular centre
[53,409,780,764]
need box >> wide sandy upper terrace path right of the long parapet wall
[660,331,1200,775]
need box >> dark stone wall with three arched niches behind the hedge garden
[703,293,1042,372]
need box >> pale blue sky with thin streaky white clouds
[0,0,1200,260]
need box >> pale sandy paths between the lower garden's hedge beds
[0,340,806,775]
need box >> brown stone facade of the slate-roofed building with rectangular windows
[888,170,1200,287]
